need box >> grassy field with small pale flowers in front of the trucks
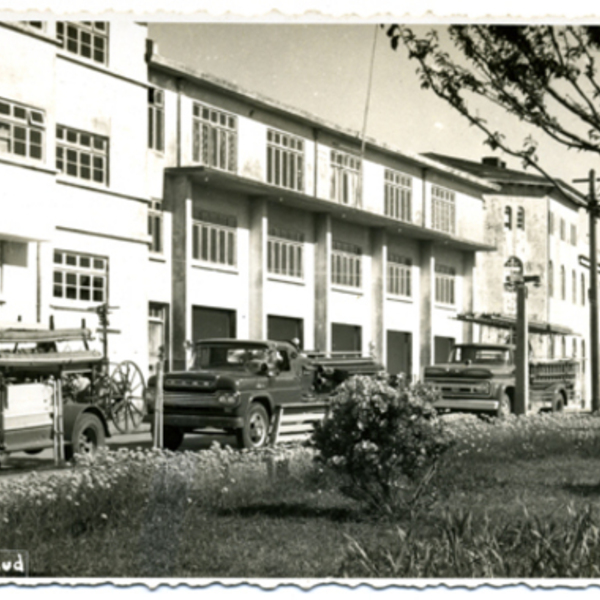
[0,415,600,578]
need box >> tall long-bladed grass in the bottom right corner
[341,507,600,578]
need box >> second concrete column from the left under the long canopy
[249,198,268,340]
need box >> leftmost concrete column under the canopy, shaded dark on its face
[164,176,192,370]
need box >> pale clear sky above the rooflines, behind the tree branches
[149,23,600,193]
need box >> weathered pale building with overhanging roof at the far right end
[427,153,590,406]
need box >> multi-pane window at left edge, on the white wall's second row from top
[0,100,45,160]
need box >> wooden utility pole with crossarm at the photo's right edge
[573,169,600,412]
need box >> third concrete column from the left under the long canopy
[315,214,331,352]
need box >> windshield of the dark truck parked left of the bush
[194,344,271,373]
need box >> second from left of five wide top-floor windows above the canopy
[267,129,304,192]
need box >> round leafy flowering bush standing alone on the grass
[312,376,451,514]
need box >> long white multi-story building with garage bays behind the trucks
[0,21,510,384]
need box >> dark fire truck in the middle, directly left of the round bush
[146,339,382,450]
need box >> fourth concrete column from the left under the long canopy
[371,229,387,364]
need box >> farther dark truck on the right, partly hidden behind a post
[424,344,579,417]
